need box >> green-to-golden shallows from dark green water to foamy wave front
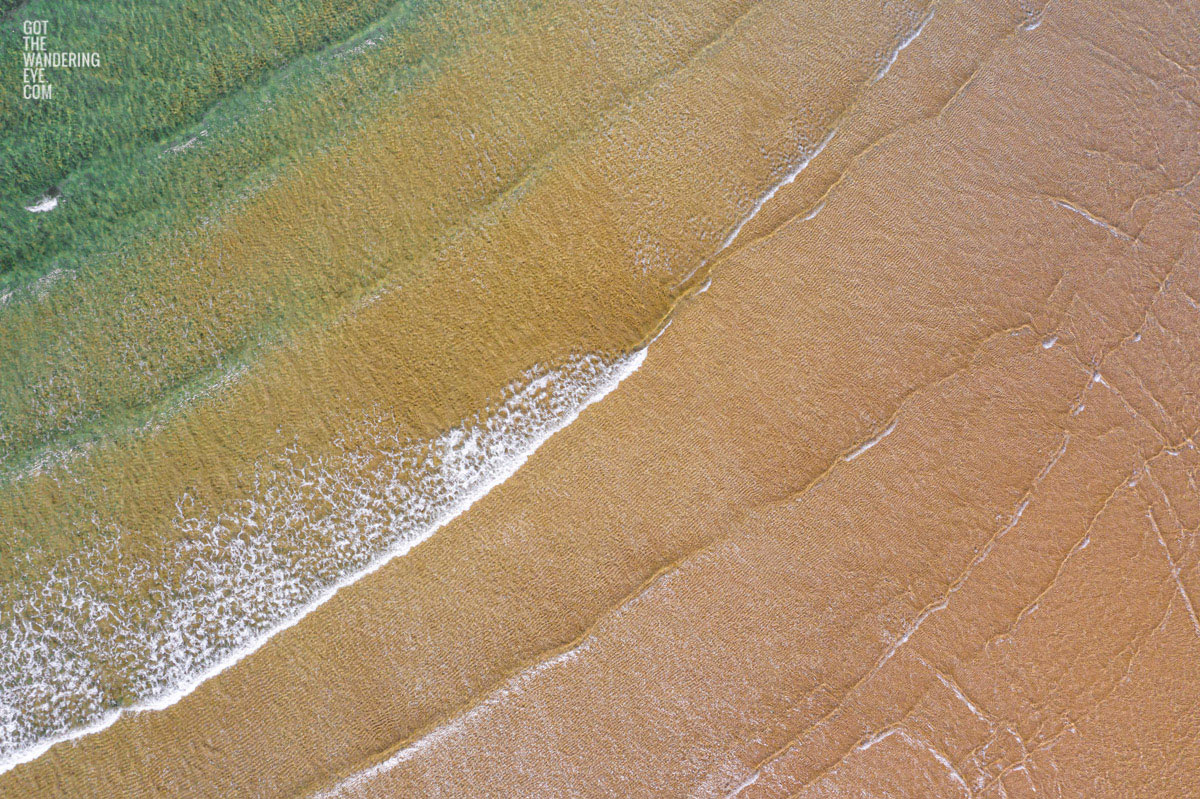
[0,2,928,765]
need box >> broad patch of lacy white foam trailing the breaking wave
[0,349,644,773]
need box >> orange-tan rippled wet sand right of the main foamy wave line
[0,0,1200,799]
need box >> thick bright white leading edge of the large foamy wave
[0,348,646,774]
